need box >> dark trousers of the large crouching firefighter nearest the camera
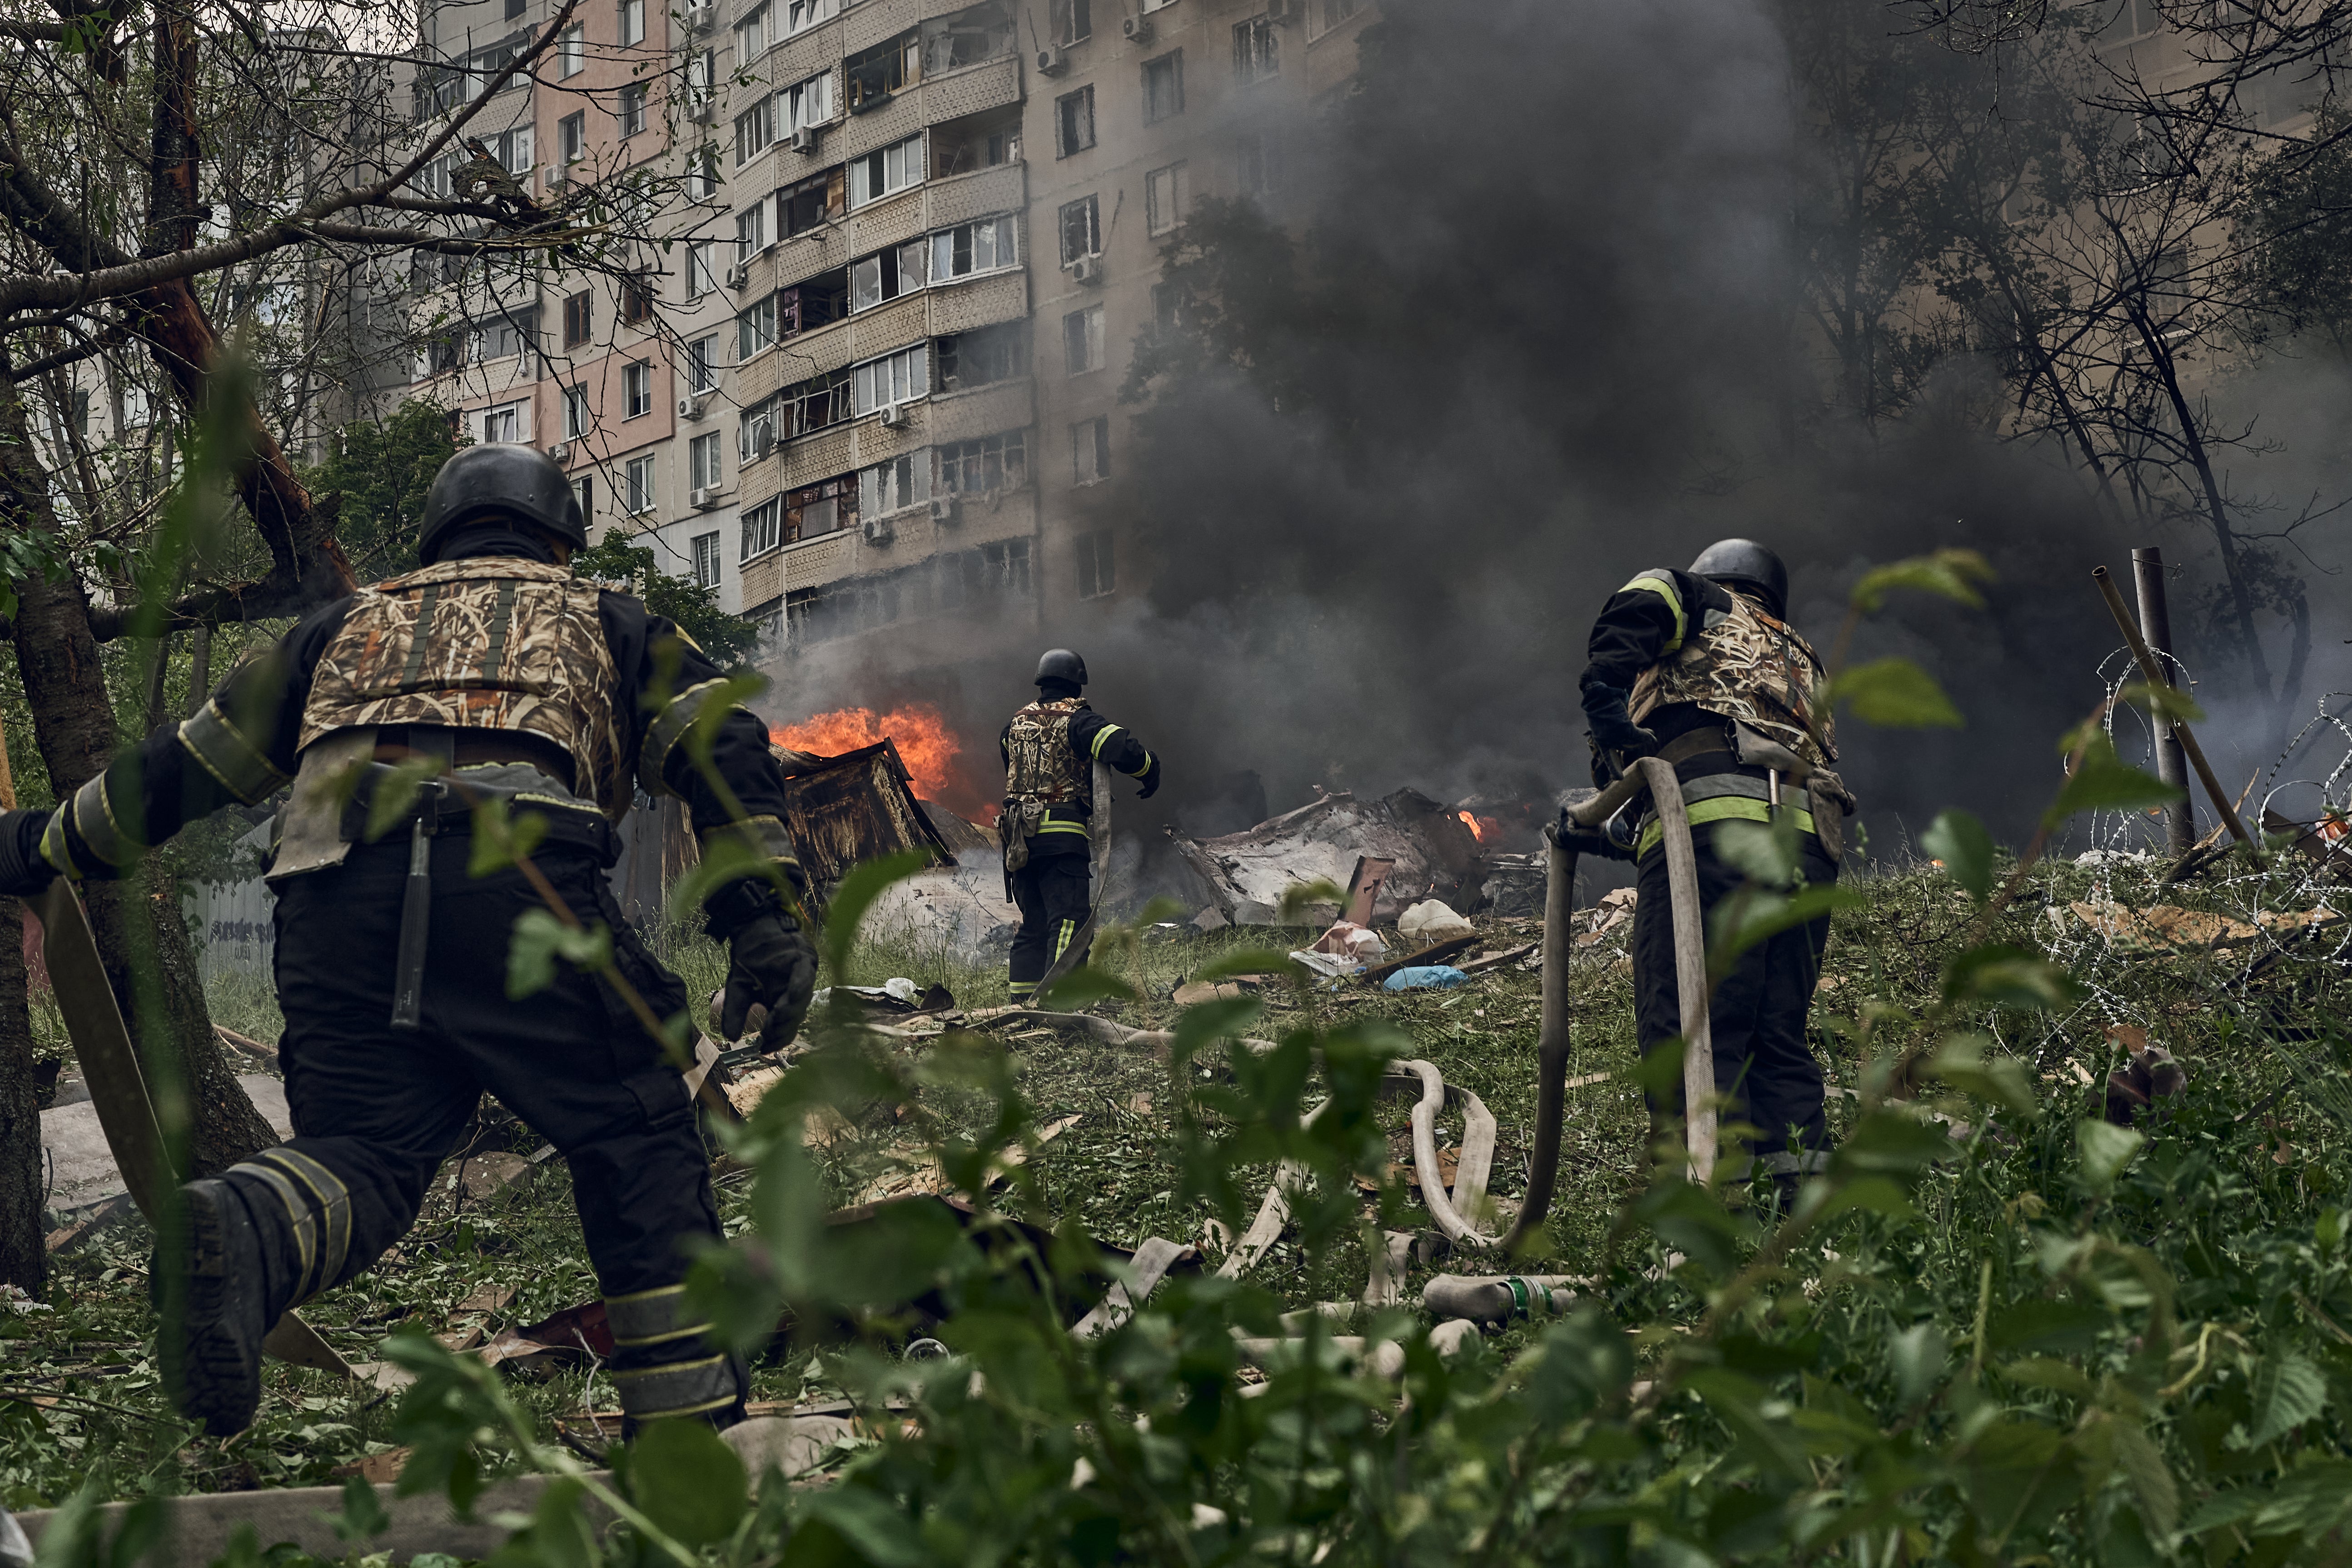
[247,832,720,1401]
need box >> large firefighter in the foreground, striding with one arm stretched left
[0,447,816,1434]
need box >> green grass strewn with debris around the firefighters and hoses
[0,865,2352,1507]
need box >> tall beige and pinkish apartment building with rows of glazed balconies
[378,0,1371,658]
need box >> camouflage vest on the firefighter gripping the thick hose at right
[1632,592,1837,767]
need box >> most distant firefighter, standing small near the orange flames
[997,649,1159,1001]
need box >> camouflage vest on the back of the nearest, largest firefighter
[296,557,633,821]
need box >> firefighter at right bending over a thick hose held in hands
[1562,538,1853,1197]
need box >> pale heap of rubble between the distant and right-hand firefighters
[1171,790,1484,926]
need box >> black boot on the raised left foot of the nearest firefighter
[148,1178,278,1436]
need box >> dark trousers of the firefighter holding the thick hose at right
[1632,823,1837,1178]
